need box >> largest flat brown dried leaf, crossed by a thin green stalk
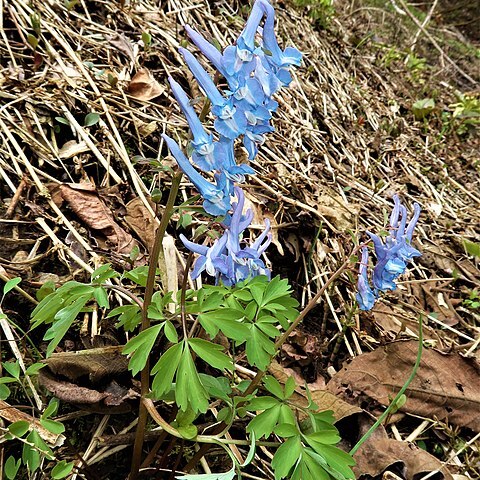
[327,340,480,431]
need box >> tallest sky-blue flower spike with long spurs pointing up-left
[163,0,301,216]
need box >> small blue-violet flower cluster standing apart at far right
[356,195,421,310]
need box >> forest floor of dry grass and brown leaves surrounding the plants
[0,0,480,480]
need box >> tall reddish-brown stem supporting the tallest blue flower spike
[129,173,182,480]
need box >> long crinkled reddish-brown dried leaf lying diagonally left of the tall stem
[50,183,137,254]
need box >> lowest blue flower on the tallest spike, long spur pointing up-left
[162,134,231,216]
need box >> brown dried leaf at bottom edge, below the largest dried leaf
[353,438,453,480]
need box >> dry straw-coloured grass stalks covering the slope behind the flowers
[0,0,480,476]
